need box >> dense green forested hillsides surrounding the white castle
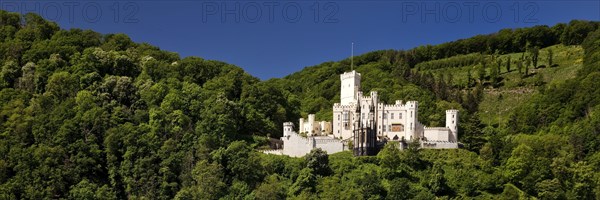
[0,11,600,199]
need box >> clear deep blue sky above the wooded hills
[0,0,600,79]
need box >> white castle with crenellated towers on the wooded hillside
[265,70,458,157]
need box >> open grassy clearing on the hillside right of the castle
[424,45,583,125]
